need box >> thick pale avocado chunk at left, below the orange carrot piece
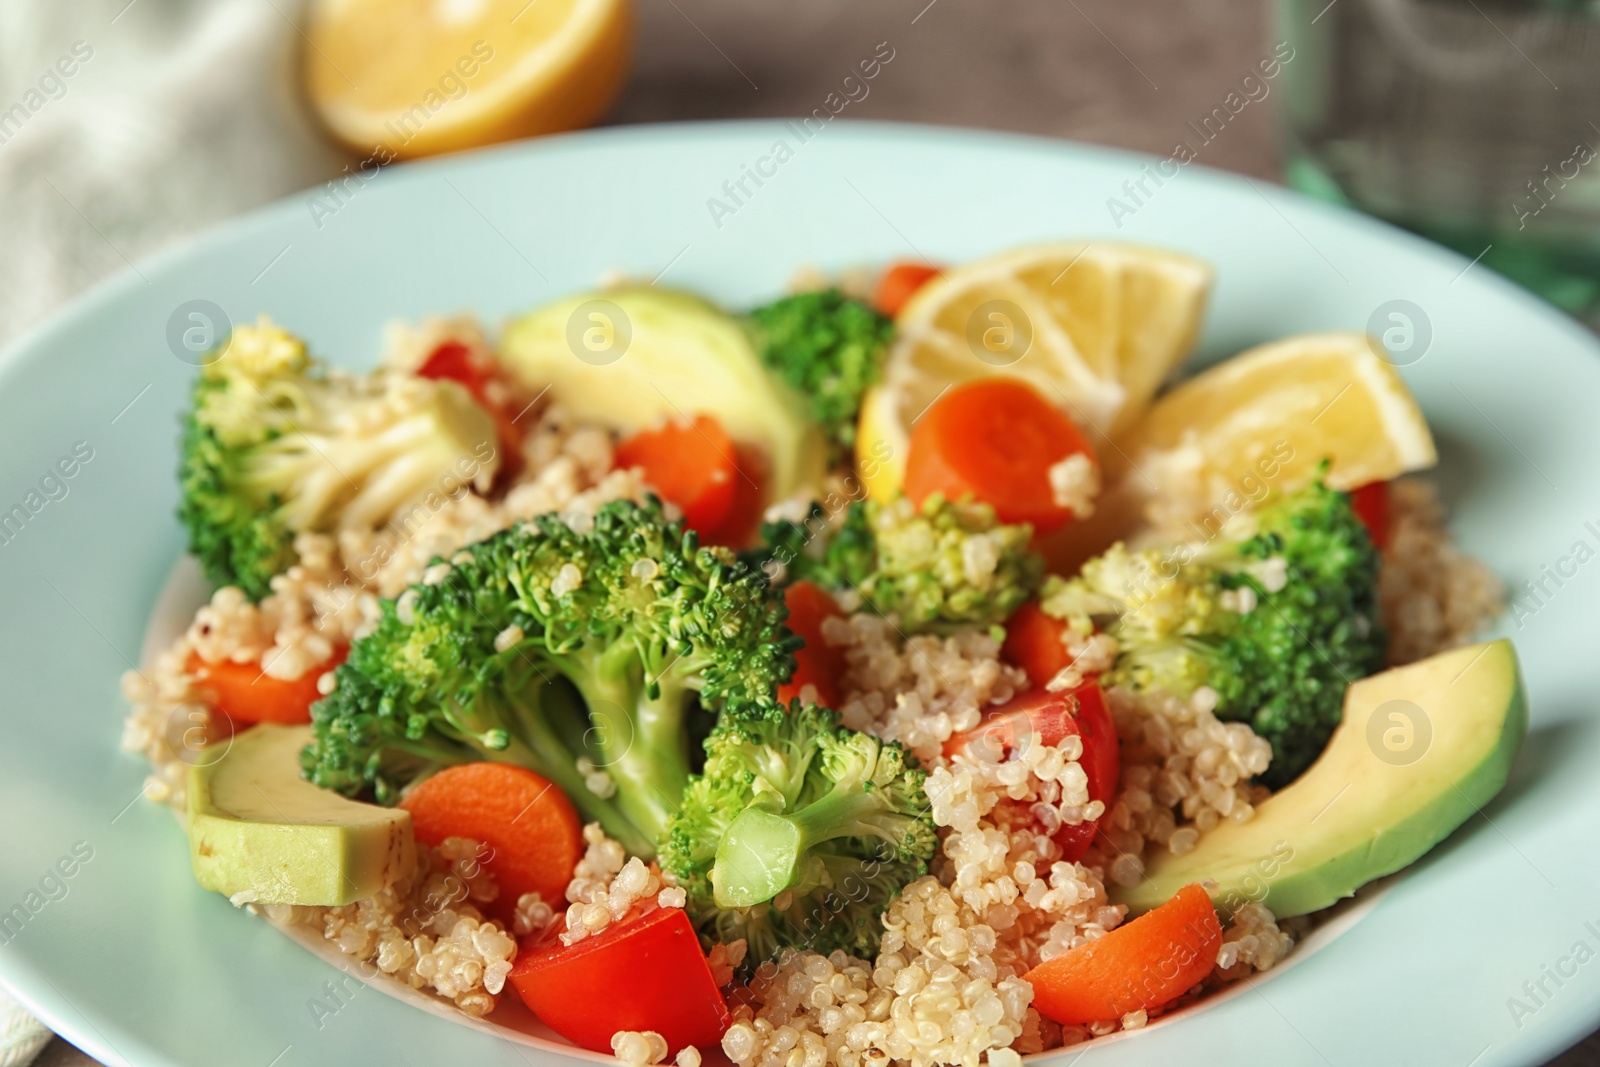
[189,723,416,905]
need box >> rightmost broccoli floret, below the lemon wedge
[1043,482,1384,789]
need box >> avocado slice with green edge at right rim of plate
[1110,640,1528,918]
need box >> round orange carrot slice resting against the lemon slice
[906,378,1099,536]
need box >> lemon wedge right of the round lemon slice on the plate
[1123,333,1438,525]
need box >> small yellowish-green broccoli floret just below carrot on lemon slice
[744,494,1045,633]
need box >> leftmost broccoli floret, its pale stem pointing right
[178,320,499,600]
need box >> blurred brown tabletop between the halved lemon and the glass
[37,0,1600,1067]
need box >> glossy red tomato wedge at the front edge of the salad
[510,907,728,1057]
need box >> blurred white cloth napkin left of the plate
[0,0,349,1049]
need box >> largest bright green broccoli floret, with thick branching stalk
[302,501,798,857]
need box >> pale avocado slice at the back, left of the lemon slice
[501,288,827,502]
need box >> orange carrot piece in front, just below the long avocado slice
[1022,885,1222,1025]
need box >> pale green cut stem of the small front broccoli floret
[710,787,899,907]
